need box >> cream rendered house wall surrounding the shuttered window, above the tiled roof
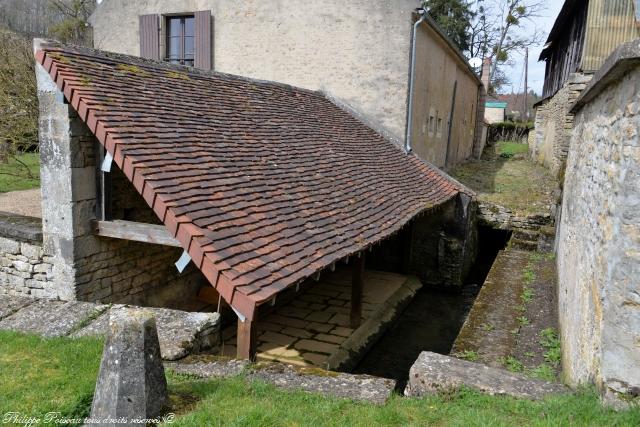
[91,0,420,141]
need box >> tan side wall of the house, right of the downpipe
[411,24,480,167]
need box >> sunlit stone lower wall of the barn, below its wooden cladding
[529,73,592,175]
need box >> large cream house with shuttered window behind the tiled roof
[90,0,484,171]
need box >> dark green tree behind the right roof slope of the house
[424,0,474,51]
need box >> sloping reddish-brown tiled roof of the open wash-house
[36,42,471,318]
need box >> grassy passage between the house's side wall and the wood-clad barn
[451,142,557,215]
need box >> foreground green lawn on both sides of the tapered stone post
[0,332,640,427]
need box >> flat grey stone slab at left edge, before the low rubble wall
[0,299,107,337]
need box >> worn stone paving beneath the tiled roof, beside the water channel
[222,267,407,369]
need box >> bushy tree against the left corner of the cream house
[49,0,96,45]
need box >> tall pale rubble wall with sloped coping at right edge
[557,42,640,403]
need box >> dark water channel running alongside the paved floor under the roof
[353,227,511,391]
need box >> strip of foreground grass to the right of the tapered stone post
[166,376,640,427]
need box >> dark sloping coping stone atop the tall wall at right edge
[571,39,640,114]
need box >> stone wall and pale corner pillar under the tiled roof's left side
[36,60,204,308]
